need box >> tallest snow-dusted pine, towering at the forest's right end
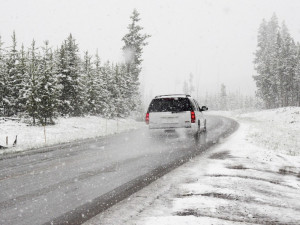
[122,9,150,111]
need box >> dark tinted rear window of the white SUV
[148,98,193,112]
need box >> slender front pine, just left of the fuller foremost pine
[26,40,41,125]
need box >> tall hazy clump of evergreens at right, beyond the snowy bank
[254,14,299,108]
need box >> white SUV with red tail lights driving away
[146,94,208,133]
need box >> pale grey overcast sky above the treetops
[0,0,300,101]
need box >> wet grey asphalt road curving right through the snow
[0,116,238,225]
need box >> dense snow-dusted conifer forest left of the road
[0,10,150,125]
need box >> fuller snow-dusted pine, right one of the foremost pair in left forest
[38,41,59,125]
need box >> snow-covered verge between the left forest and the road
[0,116,145,154]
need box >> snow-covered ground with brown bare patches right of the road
[86,107,300,225]
